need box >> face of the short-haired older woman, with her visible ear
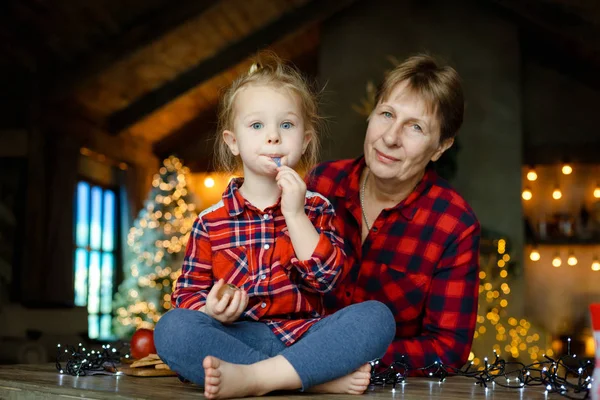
[364,82,453,185]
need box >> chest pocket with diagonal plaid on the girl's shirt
[213,246,251,288]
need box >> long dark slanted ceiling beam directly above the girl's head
[107,0,354,134]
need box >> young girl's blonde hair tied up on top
[215,52,322,173]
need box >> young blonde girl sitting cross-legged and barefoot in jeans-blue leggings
[154,56,395,399]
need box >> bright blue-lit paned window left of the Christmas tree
[74,181,118,340]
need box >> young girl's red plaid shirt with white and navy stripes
[171,178,345,346]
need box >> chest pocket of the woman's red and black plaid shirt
[381,263,431,320]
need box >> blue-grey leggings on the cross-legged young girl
[154,300,396,390]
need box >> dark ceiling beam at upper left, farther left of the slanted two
[40,0,218,96]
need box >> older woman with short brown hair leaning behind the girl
[307,56,480,368]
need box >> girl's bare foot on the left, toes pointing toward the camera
[202,356,265,399]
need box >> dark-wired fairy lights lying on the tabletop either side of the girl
[55,342,594,399]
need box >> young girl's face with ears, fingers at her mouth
[223,85,310,178]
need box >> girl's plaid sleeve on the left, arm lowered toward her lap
[171,217,214,310]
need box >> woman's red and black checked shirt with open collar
[307,157,480,368]
